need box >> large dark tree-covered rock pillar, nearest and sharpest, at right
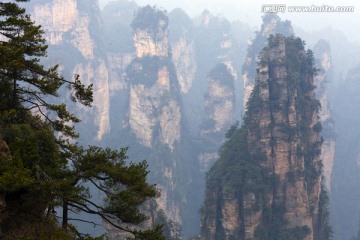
[202,35,329,240]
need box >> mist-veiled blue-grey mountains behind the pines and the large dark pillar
[20,0,360,239]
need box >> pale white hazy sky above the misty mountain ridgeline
[99,0,360,43]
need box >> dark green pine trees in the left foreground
[0,0,164,240]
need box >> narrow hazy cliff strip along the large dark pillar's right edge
[314,40,336,191]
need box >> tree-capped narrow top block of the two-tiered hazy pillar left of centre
[131,5,169,57]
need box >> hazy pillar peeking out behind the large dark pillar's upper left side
[242,14,294,108]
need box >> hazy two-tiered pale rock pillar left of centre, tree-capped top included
[127,6,182,150]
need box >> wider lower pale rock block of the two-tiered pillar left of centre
[128,58,181,149]
